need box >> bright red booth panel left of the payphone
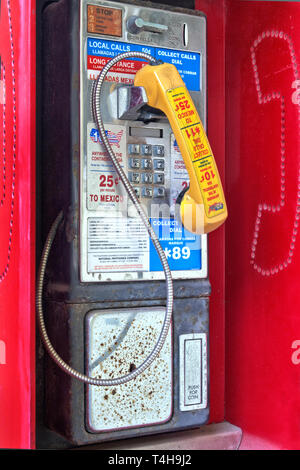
[0,0,35,448]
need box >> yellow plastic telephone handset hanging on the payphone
[134,63,227,234]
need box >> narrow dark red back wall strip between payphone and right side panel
[196,0,226,422]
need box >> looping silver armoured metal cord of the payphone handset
[36,52,174,386]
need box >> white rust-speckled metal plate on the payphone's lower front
[86,307,173,432]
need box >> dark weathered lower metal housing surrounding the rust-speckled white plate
[39,296,210,448]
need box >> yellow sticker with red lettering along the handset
[167,87,226,217]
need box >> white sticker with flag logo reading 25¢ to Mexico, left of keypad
[87,123,127,213]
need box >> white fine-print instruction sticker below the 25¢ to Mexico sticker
[88,217,149,273]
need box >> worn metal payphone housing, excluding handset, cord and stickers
[38,0,210,448]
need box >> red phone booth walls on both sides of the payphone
[0,0,300,449]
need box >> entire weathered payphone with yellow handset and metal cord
[37,0,227,445]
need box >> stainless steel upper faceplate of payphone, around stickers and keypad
[80,0,207,282]
